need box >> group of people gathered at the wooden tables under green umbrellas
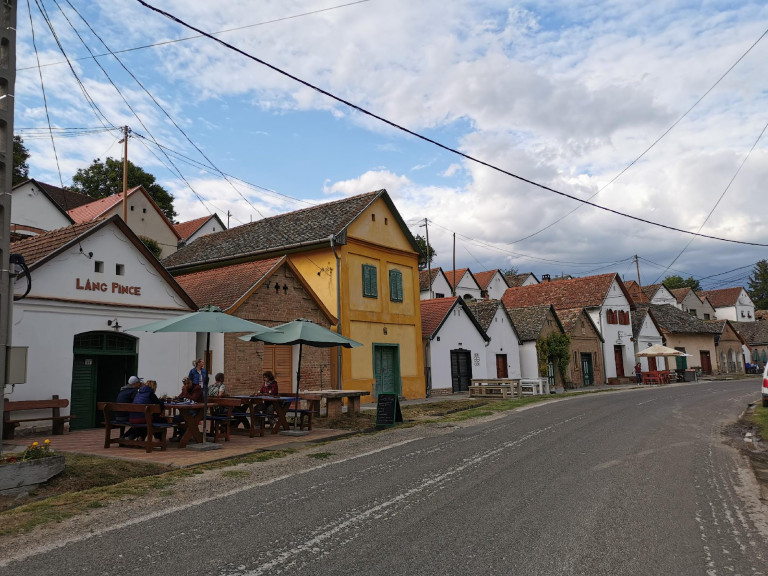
[115,359,279,442]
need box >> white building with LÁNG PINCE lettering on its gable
[8,216,196,428]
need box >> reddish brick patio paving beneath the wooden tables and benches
[3,427,350,468]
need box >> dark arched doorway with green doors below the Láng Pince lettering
[70,332,139,430]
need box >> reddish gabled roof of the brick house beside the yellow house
[176,256,337,324]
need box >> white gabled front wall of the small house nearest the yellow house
[429,306,488,390]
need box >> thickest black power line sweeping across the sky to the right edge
[136,0,768,247]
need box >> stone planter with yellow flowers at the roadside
[0,439,64,494]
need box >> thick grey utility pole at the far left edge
[0,0,16,456]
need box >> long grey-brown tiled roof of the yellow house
[163,190,396,268]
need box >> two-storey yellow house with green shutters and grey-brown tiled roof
[163,190,426,402]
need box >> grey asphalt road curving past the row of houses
[0,380,768,576]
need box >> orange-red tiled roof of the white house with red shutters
[502,273,621,310]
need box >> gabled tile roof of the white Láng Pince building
[11,215,195,309]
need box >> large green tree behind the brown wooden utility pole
[70,158,176,222]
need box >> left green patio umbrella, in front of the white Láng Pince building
[127,305,275,444]
